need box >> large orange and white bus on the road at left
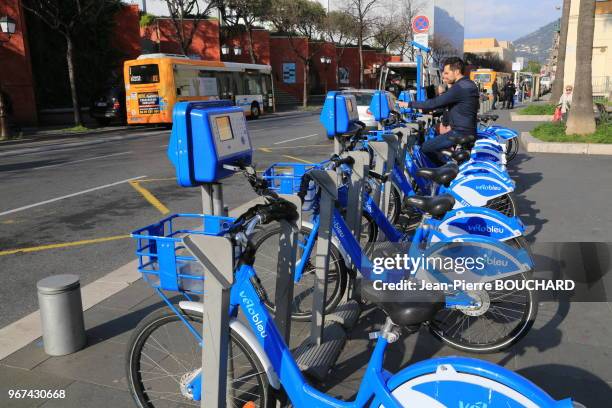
[123,54,274,125]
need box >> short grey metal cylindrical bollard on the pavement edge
[36,275,86,356]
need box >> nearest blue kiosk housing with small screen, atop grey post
[168,100,253,187]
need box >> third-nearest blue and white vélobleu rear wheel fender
[429,207,525,243]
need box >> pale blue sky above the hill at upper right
[465,0,563,41]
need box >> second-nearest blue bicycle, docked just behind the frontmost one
[250,158,538,353]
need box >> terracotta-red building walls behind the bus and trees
[0,0,393,124]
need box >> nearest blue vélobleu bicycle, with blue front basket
[127,199,581,408]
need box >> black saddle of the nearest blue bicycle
[361,279,445,326]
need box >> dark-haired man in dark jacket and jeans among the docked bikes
[408,57,480,165]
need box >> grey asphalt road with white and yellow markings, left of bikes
[0,114,333,327]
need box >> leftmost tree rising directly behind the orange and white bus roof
[164,0,216,55]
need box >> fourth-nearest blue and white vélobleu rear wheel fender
[447,174,514,208]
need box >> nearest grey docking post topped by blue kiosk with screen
[160,101,300,408]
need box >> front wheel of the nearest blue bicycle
[126,308,268,408]
